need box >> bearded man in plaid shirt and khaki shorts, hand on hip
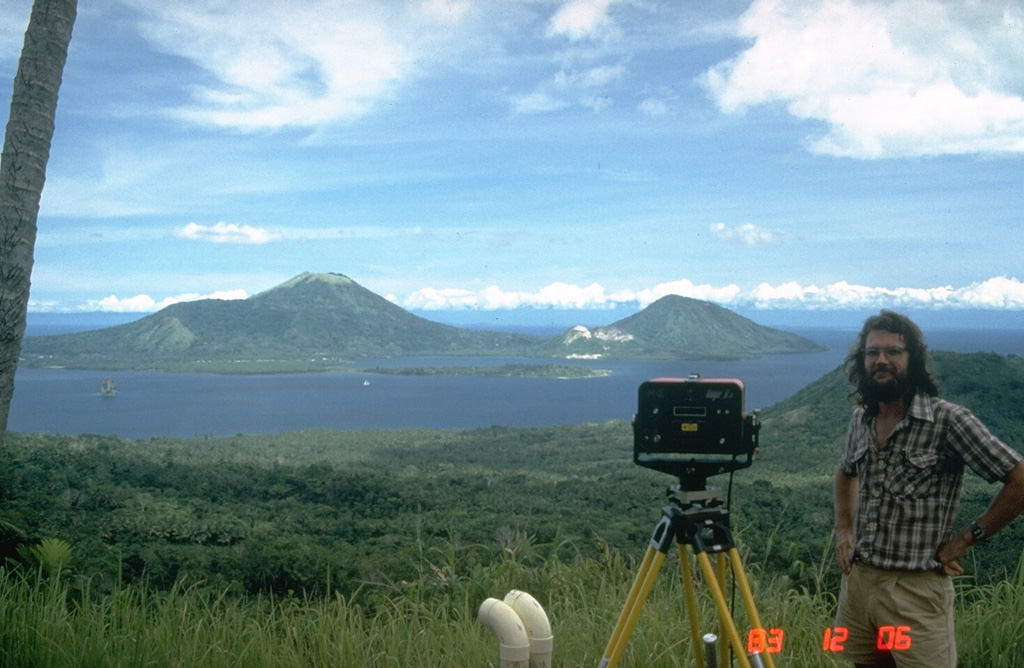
[834,310,1024,668]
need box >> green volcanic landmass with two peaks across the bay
[22,274,820,373]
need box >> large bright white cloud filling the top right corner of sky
[703,0,1024,158]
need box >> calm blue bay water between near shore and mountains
[8,329,1024,439]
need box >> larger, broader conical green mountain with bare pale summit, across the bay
[23,274,541,368]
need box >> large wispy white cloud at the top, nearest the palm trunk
[122,0,473,131]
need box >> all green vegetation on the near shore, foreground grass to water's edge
[0,352,1024,668]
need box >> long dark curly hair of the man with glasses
[843,310,939,415]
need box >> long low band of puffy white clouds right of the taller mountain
[390,277,1024,310]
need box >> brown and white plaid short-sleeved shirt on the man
[840,394,1021,571]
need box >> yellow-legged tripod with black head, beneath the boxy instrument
[599,486,775,668]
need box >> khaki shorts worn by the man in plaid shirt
[836,563,956,668]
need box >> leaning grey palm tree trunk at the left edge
[0,0,78,448]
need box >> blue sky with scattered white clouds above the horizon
[0,0,1024,320]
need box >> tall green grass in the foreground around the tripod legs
[0,551,1024,668]
